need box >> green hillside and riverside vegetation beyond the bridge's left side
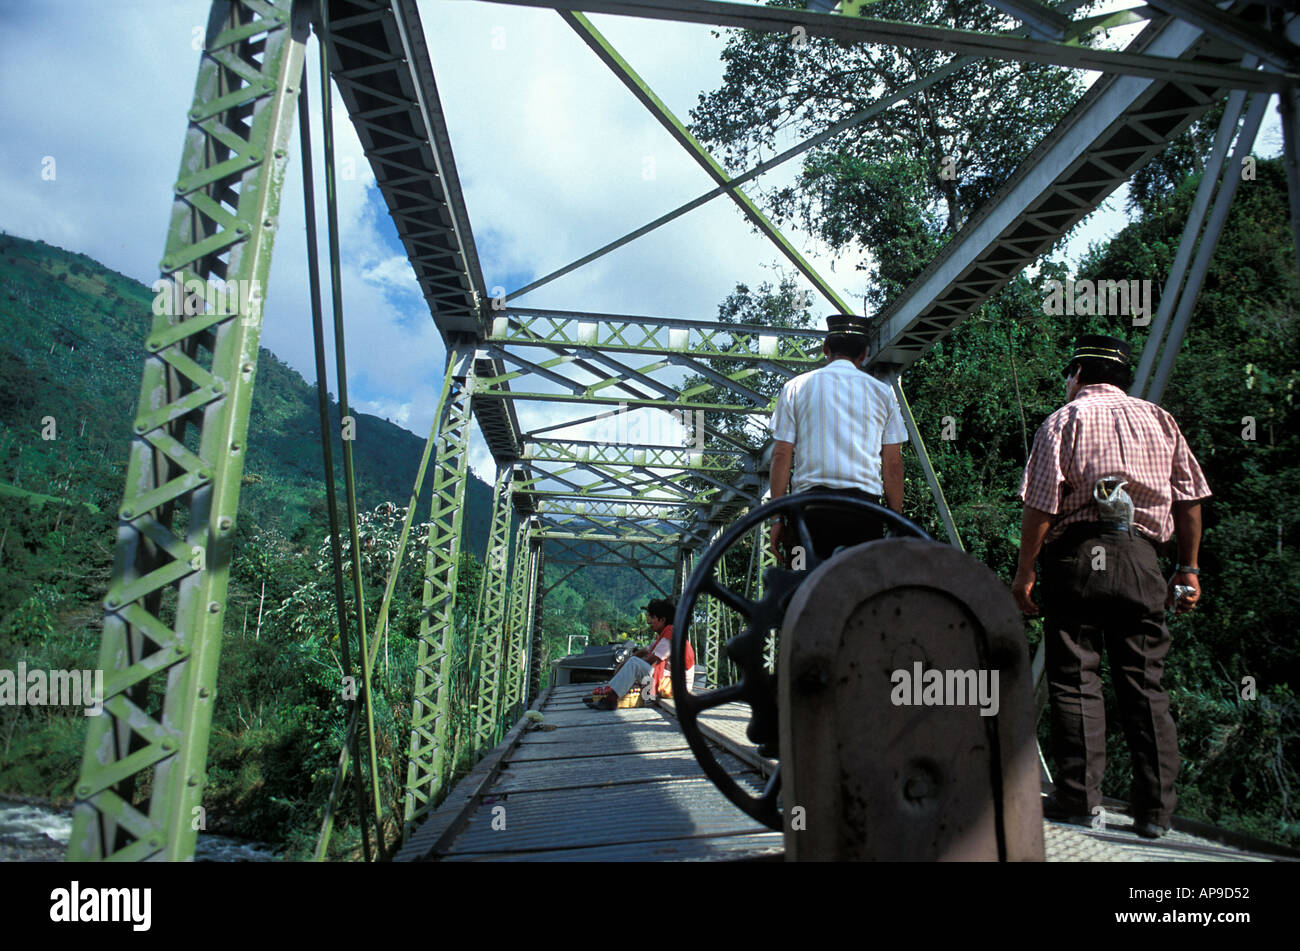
[0,229,665,857]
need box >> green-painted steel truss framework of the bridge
[69,0,1300,860]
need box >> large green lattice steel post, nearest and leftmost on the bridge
[68,0,309,861]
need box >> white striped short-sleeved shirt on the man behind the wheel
[772,360,907,495]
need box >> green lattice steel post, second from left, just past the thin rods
[403,348,473,838]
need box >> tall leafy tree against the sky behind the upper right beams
[690,0,1082,307]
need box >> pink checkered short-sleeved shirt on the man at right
[1021,383,1210,542]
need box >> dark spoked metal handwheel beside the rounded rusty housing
[671,490,931,831]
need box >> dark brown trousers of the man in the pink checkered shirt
[1041,524,1179,825]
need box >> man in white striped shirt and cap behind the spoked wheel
[771,314,907,560]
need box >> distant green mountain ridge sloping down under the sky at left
[0,235,491,559]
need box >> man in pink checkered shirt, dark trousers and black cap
[1011,335,1210,838]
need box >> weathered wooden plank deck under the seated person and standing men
[397,686,1294,861]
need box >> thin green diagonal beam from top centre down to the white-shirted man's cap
[556,10,855,313]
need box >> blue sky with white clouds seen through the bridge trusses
[0,0,1281,478]
